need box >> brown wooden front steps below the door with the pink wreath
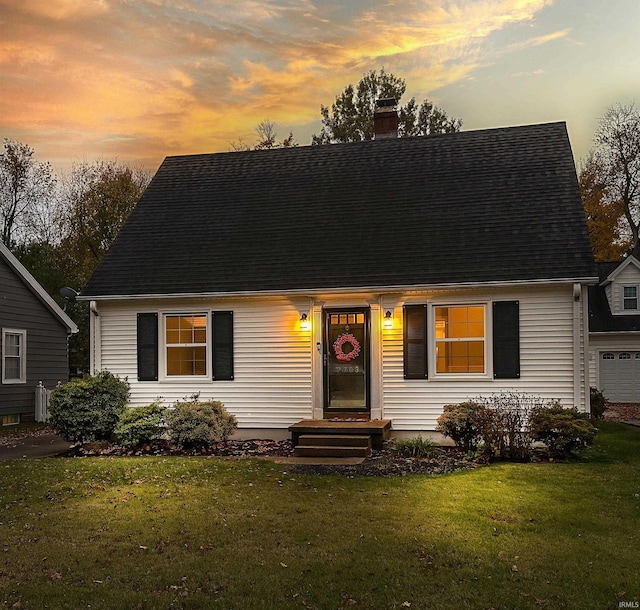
[289,419,391,457]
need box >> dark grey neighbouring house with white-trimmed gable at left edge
[0,243,78,425]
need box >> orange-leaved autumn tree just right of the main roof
[578,153,631,261]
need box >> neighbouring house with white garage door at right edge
[589,256,640,402]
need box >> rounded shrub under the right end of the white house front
[529,401,598,457]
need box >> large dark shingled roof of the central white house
[83,123,596,297]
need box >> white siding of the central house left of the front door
[99,299,312,428]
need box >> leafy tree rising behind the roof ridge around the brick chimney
[312,68,462,144]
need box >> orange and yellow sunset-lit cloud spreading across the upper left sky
[0,0,608,167]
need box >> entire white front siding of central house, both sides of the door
[93,284,587,432]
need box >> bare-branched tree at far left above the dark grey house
[0,138,56,248]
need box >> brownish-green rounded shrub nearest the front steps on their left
[166,395,238,448]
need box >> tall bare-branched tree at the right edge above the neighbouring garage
[593,104,640,258]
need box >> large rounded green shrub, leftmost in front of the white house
[49,371,129,443]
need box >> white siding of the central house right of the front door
[383,286,585,430]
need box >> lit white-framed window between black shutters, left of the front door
[165,314,207,376]
